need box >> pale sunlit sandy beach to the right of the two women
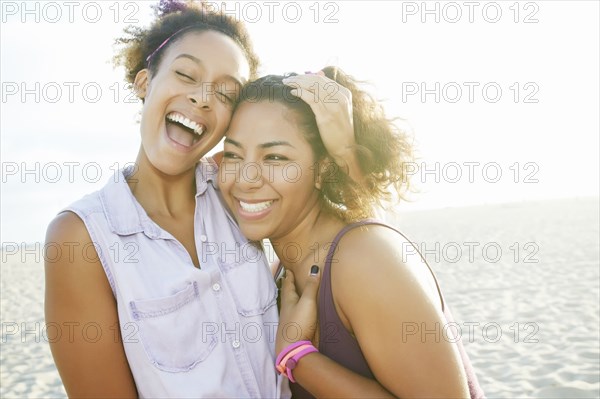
[397,199,600,398]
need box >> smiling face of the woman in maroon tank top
[219,102,319,240]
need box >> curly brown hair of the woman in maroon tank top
[238,67,413,222]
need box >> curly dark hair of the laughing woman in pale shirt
[114,0,259,84]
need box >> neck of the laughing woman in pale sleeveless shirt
[127,148,196,217]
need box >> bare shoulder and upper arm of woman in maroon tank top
[324,225,468,397]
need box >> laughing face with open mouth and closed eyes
[135,31,249,175]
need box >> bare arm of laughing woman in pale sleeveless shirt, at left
[45,212,137,398]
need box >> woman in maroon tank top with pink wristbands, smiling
[219,68,483,398]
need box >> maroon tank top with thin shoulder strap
[290,219,485,399]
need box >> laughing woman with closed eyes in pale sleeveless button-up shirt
[45,1,354,398]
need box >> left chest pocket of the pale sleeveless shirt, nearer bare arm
[129,281,217,372]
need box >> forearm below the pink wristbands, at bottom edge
[293,353,394,398]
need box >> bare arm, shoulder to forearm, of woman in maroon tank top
[276,228,469,398]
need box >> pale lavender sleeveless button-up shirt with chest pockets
[66,160,290,398]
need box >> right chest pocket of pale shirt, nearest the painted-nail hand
[220,244,277,317]
